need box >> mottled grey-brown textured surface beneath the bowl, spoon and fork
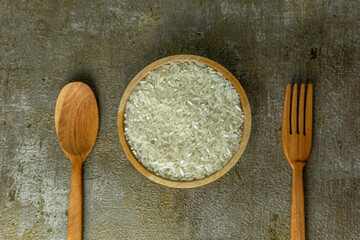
[0,0,360,240]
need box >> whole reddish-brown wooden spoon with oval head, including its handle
[55,82,99,239]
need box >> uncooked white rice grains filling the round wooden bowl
[124,61,244,181]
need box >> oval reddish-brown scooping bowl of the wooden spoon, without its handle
[55,82,99,160]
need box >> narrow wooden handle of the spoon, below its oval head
[68,162,83,240]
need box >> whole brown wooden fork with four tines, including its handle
[282,84,313,240]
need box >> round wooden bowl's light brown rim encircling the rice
[117,55,251,188]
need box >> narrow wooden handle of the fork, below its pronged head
[291,162,305,240]
